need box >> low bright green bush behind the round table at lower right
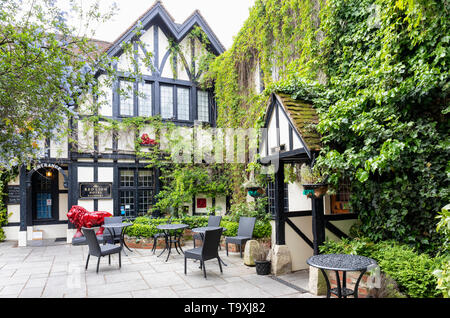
[320,239,444,298]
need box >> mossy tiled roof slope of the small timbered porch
[268,93,321,152]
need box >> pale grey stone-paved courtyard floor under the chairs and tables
[0,241,320,298]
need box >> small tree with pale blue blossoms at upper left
[0,0,116,170]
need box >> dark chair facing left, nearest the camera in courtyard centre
[184,228,223,278]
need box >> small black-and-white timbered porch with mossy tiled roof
[259,93,356,271]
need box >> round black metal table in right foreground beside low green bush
[306,254,377,298]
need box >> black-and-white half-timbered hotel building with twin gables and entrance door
[5,1,226,246]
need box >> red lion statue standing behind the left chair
[67,205,112,238]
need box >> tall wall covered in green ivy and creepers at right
[208,0,450,252]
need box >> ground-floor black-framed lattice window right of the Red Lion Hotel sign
[119,169,155,217]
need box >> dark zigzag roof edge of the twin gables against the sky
[105,0,225,56]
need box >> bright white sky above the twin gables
[59,0,255,49]
